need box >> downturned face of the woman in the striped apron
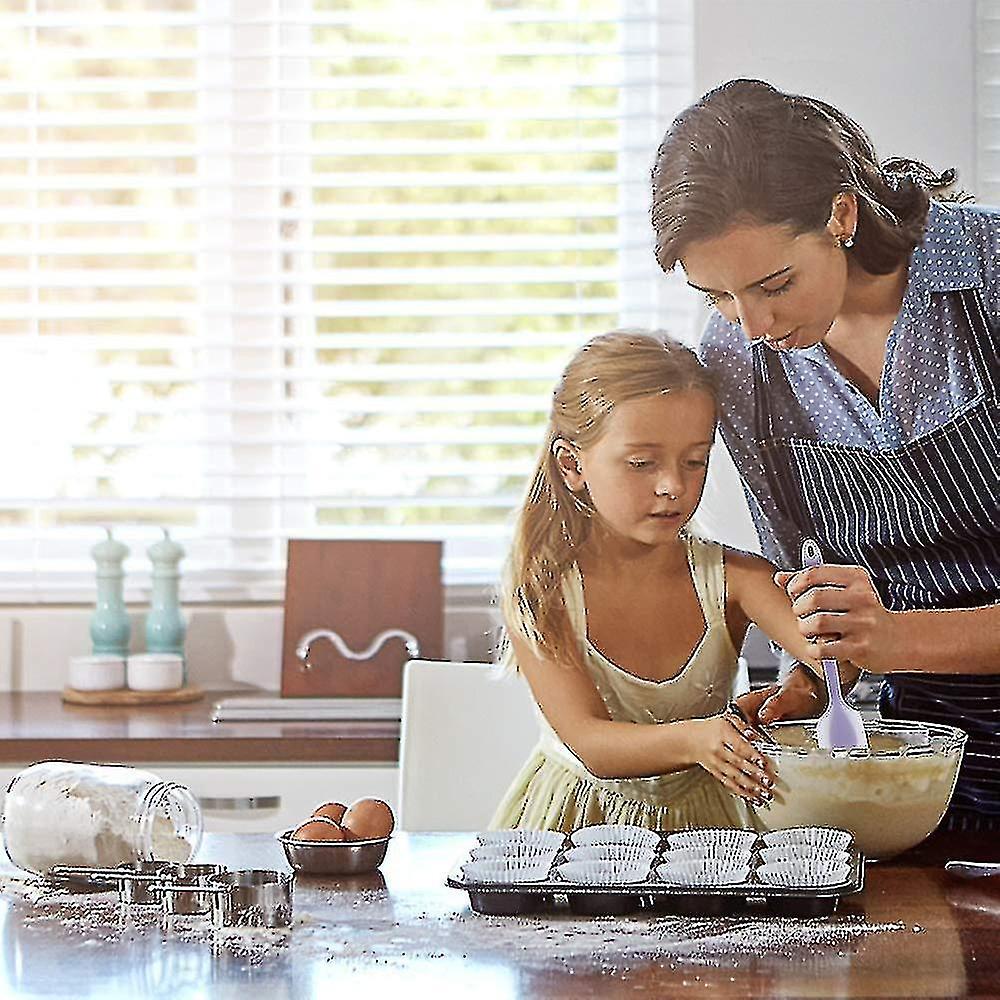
[681,224,853,351]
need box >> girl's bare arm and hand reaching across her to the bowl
[510,635,774,799]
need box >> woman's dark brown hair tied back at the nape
[652,80,968,274]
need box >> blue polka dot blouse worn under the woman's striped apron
[700,203,1000,566]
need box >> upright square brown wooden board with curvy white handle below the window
[281,539,444,698]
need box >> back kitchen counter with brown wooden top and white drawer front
[0,692,399,833]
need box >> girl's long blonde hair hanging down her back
[499,330,715,666]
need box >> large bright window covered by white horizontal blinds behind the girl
[0,0,692,600]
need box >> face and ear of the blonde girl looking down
[557,389,715,545]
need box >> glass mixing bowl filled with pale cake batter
[754,719,967,858]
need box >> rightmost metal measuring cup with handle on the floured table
[159,868,293,930]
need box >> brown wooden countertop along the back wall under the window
[0,690,399,765]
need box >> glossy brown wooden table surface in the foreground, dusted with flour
[0,834,1000,1000]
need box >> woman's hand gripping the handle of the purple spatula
[774,564,901,672]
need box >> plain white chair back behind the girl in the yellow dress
[398,660,538,831]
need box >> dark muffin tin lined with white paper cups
[447,826,864,917]
